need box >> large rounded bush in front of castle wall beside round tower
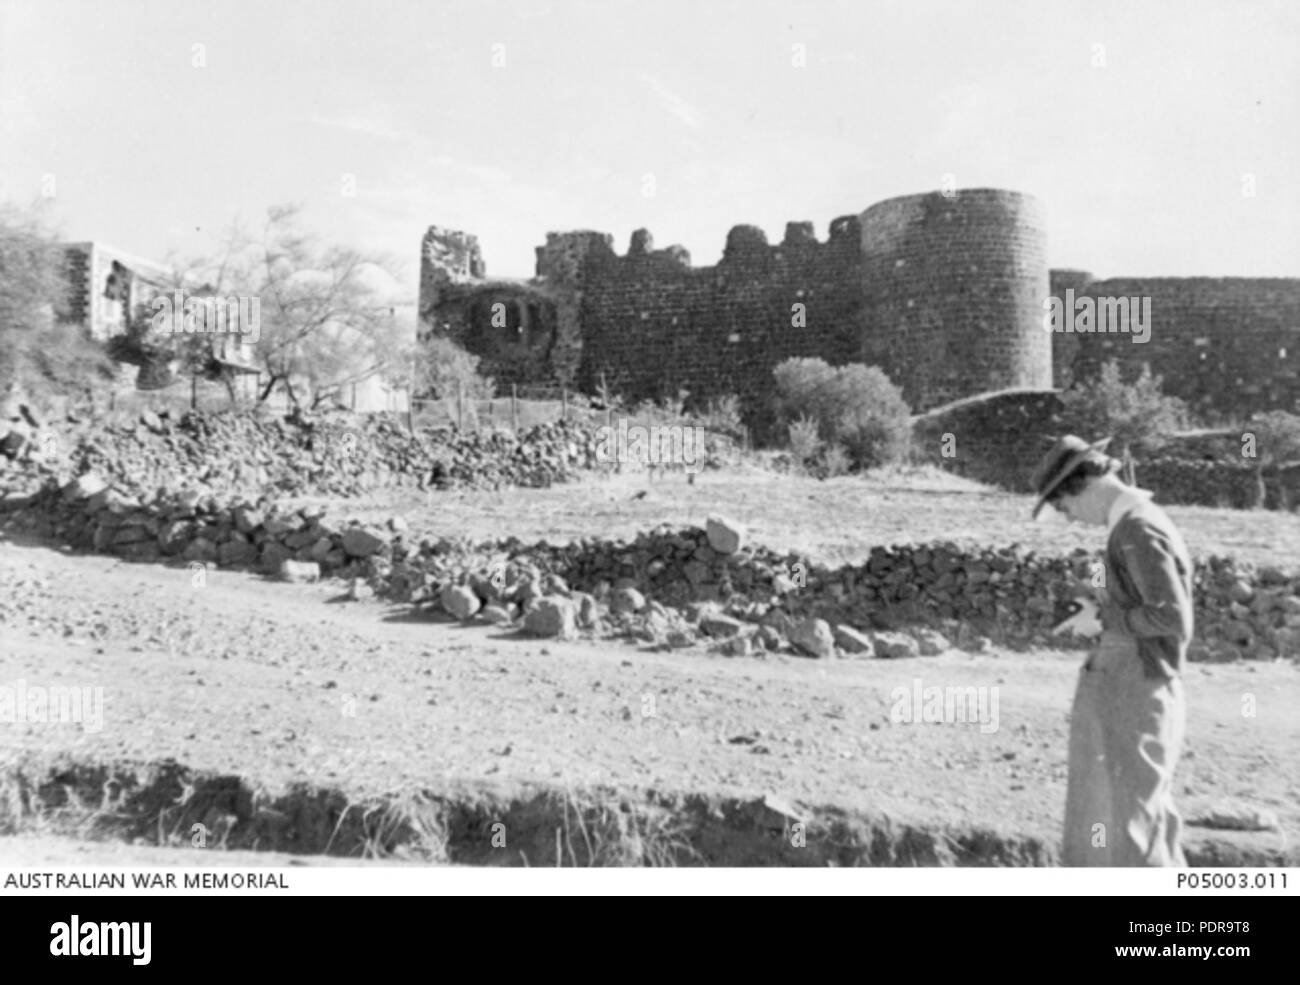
[774,359,911,469]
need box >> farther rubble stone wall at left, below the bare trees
[0,411,743,502]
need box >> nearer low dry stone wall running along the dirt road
[8,474,1300,659]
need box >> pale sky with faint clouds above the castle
[0,0,1300,301]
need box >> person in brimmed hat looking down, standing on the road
[1034,435,1192,865]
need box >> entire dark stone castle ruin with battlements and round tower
[419,188,1300,428]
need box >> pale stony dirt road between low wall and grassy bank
[0,542,1300,855]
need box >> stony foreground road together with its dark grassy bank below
[0,527,1300,864]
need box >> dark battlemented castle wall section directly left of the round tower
[566,217,862,423]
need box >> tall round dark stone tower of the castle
[861,188,1052,411]
